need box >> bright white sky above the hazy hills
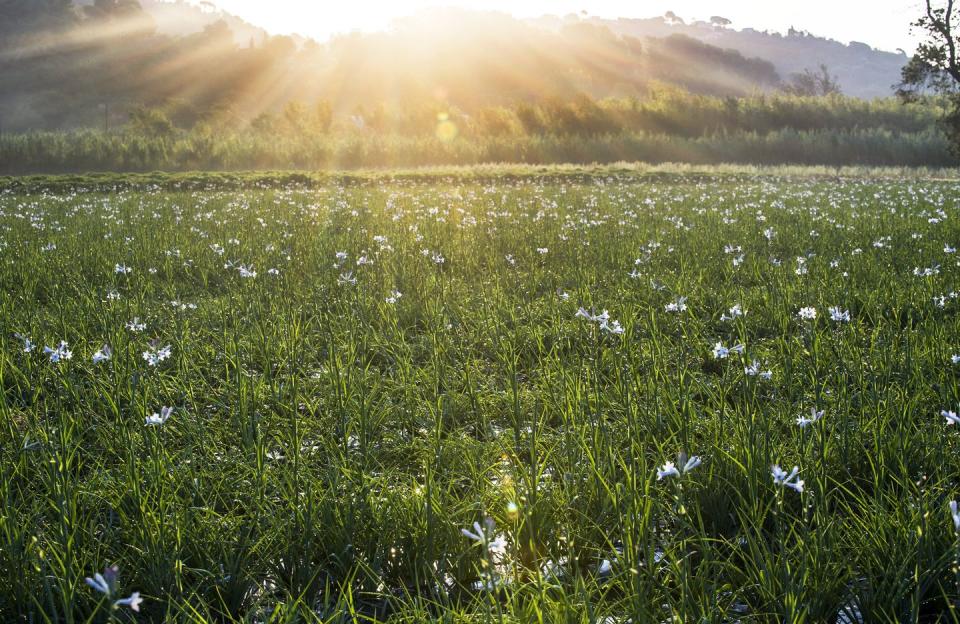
[206,0,920,53]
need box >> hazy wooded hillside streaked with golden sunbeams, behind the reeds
[0,0,916,131]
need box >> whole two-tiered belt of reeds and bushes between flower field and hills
[0,88,954,174]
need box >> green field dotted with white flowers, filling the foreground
[0,167,960,624]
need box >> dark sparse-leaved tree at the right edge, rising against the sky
[897,0,960,155]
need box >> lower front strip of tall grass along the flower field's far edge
[0,129,955,175]
